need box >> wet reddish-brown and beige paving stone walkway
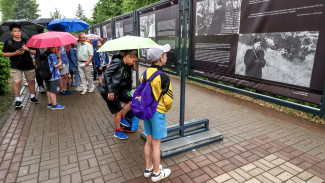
[0,68,325,183]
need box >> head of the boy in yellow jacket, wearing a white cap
[147,44,170,66]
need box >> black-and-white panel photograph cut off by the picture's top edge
[195,0,241,36]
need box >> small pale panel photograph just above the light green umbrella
[140,13,156,37]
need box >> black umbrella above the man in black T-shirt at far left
[0,19,44,42]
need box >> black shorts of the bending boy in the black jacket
[101,90,132,114]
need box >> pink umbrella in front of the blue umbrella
[26,32,77,48]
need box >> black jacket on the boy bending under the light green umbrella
[99,55,132,95]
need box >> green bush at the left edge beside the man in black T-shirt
[0,45,10,95]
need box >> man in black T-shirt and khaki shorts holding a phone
[2,24,38,109]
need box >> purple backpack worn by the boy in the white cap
[131,71,163,120]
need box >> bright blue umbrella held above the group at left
[46,18,89,32]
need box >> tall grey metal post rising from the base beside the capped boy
[180,0,188,137]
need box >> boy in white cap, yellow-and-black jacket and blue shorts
[140,44,173,182]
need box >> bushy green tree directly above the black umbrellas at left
[12,0,40,20]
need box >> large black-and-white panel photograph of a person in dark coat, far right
[235,31,319,87]
